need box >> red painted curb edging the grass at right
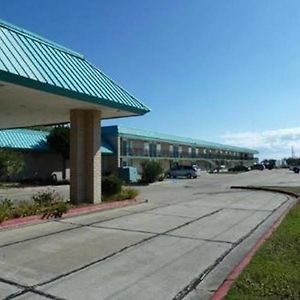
[211,200,294,300]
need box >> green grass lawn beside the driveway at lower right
[225,186,300,300]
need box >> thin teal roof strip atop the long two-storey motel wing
[102,126,258,154]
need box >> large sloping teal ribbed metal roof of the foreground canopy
[0,20,149,114]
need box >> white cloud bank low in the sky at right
[221,127,300,158]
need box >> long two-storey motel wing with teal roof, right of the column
[102,126,258,173]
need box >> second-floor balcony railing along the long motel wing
[121,148,255,161]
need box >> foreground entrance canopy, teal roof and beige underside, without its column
[0,20,149,128]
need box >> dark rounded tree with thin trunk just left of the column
[47,126,70,180]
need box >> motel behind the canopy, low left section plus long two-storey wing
[0,126,258,181]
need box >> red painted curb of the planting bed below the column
[0,199,139,230]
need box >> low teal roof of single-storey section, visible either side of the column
[0,129,113,154]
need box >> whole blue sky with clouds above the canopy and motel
[0,0,300,158]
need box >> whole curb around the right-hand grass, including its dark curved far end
[211,186,298,300]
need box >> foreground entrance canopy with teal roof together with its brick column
[0,20,149,203]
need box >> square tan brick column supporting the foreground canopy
[70,109,101,204]
